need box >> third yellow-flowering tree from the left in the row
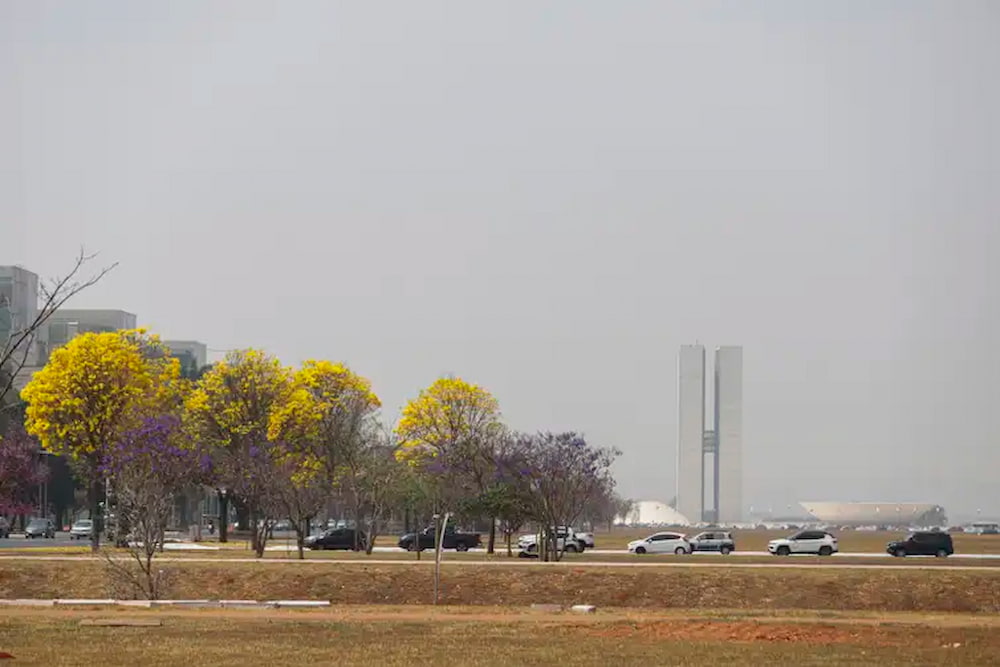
[269,360,381,547]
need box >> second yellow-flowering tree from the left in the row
[184,349,293,556]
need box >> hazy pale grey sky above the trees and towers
[0,0,1000,516]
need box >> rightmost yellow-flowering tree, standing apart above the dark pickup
[396,377,506,550]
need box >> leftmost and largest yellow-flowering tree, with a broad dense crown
[21,329,184,550]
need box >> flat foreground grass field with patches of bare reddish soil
[0,607,1000,666]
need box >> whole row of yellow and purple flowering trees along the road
[0,330,617,596]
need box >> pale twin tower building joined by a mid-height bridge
[675,345,743,525]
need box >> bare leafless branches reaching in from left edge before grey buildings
[0,249,118,409]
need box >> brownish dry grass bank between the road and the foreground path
[0,560,1000,613]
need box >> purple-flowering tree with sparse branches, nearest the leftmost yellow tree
[99,415,204,600]
